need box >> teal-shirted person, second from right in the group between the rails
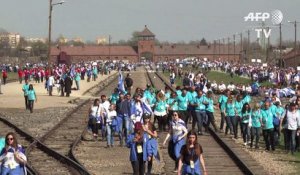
[193,90,206,135]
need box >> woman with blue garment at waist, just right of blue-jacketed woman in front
[143,114,159,175]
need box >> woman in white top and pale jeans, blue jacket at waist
[106,104,117,148]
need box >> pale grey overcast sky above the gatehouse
[0,0,300,42]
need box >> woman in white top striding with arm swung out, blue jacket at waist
[163,112,188,172]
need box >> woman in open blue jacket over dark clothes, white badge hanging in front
[126,122,149,175]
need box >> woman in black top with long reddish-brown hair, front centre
[178,130,207,175]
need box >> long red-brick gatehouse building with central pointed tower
[51,26,242,63]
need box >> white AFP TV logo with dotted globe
[244,10,283,38]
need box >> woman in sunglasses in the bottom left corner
[0,132,27,175]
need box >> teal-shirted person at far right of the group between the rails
[204,90,219,132]
